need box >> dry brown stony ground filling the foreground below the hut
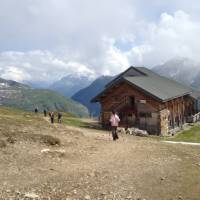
[0,108,200,200]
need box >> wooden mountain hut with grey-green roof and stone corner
[91,67,198,135]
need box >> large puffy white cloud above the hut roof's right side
[127,11,200,66]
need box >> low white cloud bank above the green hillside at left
[0,51,96,84]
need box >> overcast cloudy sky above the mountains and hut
[0,0,200,83]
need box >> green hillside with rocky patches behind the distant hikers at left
[0,79,88,116]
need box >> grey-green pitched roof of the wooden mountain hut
[92,67,192,102]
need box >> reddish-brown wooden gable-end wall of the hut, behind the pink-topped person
[101,83,160,134]
